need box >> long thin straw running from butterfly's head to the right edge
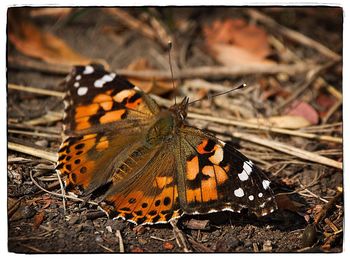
[188,113,343,143]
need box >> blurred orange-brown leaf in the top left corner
[8,9,98,65]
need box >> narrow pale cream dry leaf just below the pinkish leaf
[247,115,311,129]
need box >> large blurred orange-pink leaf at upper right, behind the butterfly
[203,19,274,66]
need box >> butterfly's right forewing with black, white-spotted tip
[177,127,277,216]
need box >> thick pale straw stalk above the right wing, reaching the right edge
[232,132,343,169]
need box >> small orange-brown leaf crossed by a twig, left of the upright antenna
[127,58,177,95]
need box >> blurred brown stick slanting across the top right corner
[246,9,341,60]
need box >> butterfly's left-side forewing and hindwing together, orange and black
[56,65,159,193]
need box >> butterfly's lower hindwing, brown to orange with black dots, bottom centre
[104,143,182,224]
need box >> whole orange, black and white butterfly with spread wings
[56,64,277,224]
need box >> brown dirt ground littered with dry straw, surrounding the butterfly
[7,7,344,253]
